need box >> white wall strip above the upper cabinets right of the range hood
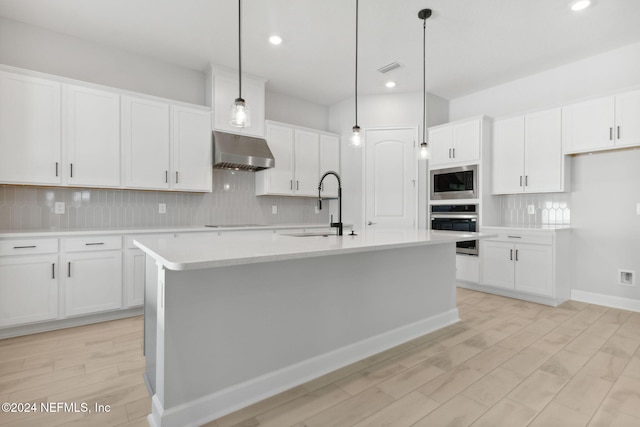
[265,90,329,131]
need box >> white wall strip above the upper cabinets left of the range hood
[0,17,205,105]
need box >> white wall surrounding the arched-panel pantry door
[329,92,449,228]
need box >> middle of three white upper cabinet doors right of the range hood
[293,129,320,196]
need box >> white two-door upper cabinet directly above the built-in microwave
[429,118,482,168]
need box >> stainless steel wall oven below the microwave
[431,205,479,255]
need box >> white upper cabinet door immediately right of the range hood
[256,123,295,195]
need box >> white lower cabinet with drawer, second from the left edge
[61,236,122,316]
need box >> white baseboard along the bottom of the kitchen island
[147,309,460,427]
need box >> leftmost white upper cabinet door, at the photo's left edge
[0,72,62,184]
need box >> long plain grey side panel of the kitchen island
[156,243,458,425]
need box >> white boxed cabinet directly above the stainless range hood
[207,66,266,138]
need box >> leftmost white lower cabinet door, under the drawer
[0,255,58,327]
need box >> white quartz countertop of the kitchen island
[134,230,495,271]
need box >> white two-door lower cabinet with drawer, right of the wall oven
[480,227,573,305]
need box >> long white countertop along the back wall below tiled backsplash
[0,223,340,238]
